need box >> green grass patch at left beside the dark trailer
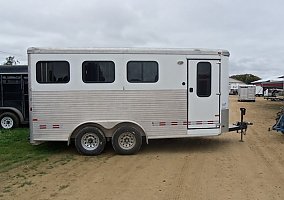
[0,128,67,173]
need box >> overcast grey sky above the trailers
[0,0,284,78]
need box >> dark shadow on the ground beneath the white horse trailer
[34,137,238,156]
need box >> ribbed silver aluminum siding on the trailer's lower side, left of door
[32,90,187,141]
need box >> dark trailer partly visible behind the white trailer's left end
[0,65,29,129]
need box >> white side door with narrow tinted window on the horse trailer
[187,60,221,129]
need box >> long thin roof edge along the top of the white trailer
[27,47,230,56]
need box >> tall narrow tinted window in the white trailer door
[196,62,211,97]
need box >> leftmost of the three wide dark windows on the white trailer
[36,61,70,83]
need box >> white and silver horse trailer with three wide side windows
[28,48,233,155]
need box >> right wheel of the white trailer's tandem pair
[112,126,142,155]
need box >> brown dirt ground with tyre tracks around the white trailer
[0,97,284,200]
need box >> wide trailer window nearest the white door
[127,61,159,83]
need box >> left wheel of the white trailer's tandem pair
[75,126,106,156]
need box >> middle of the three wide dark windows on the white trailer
[82,61,115,83]
